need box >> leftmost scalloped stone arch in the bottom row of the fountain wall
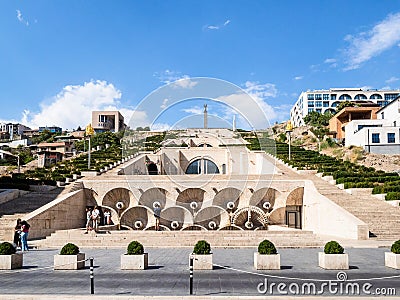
[121,206,154,230]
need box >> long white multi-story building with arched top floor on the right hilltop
[290,88,400,126]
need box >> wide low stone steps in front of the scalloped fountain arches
[34,229,325,248]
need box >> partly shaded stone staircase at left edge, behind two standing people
[0,188,63,241]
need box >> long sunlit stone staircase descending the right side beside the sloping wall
[277,158,400,241]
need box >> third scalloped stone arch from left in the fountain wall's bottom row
[194,206,230,230]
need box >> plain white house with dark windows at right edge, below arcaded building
[344,97,400,154]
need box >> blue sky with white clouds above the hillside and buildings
[0,0,400,129]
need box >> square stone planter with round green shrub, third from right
[254,240,281,270]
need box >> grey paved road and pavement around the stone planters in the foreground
[0,248,400,296]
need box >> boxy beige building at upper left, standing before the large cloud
[92,111,126,132]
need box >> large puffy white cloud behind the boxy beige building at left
[21,80,146,129]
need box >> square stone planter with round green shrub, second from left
[54,243,85,270]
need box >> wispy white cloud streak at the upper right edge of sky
[344,13,400,71]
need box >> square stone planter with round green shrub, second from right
[318,241,349,270]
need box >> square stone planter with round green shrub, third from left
[121,241,149,270]
